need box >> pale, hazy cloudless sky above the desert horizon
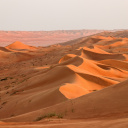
[0,0,128,31]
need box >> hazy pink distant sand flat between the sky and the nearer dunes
[0,30,102,46]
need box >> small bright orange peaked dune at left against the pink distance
[6,41,36,50]
